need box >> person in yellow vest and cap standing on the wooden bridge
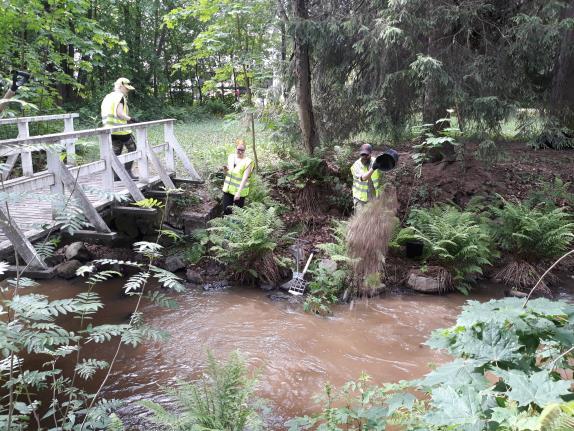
[101,78,137,181]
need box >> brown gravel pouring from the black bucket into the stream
[347,184,399,295]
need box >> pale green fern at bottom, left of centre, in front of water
[141,353,262,431]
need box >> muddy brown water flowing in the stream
[16,281,574,430]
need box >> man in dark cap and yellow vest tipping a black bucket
[351,144,381,211]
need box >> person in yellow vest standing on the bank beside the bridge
[223,140,253,215]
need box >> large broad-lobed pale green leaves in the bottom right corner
[417,298,574,431]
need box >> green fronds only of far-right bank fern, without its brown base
[492,200,574,263]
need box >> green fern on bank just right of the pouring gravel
[396,205,494,294]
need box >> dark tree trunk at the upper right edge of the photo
[549,2,574,129]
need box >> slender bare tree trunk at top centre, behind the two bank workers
[293,0,318,155]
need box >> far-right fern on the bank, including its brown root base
[492,200,574,293]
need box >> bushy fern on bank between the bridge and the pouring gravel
[207,202,288,283]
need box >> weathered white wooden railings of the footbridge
[0,114,201,267]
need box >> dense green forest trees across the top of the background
[0,0,574,152]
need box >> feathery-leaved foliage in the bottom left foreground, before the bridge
[0,195,184,431]
